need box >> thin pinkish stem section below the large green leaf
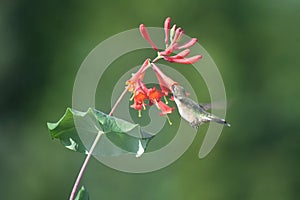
[70,131,103,200]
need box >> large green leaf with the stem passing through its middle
[47,108,153,157]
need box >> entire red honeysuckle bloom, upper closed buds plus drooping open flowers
[126,17,202,124]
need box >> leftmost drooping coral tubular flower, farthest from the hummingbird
[126,58,151,92]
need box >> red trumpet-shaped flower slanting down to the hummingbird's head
[152,63,177,96]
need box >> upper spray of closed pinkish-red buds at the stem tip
[140,17,202,64]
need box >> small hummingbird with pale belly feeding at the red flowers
[172,85,230,130]
